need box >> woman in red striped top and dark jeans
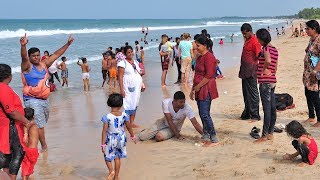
[255,29,278,143]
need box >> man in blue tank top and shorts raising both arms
[20,34,74,152]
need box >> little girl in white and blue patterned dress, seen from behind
[101,93,136,180]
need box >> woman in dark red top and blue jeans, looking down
[190,35,218,146]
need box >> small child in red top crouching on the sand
[283,121,318,166]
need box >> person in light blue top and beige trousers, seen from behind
[179,33,193,84]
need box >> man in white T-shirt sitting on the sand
[139,91,203,142]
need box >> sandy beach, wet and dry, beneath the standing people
[26,21,320,180]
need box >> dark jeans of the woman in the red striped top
[259,83,277,137]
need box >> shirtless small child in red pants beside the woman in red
[22,108,39,180]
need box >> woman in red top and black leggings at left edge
[0,64,34,179]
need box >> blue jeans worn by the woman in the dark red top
[197,94,218,143]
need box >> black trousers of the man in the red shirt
[241,77,260,120]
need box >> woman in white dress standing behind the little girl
[117,46,145,128]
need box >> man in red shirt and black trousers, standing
[239,23,261,120]
